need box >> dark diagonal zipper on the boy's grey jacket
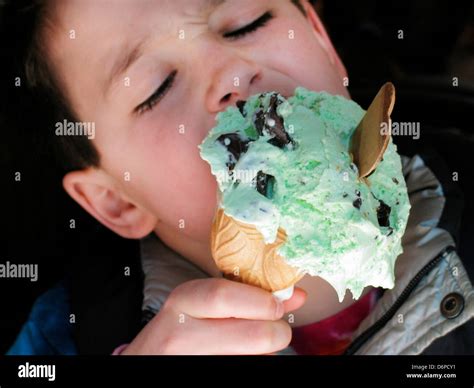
[343,245,455,355]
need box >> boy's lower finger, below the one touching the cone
[163,318,291,355]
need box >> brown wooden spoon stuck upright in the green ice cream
[350,82,395,179]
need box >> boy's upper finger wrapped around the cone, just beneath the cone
[169,279,284,320]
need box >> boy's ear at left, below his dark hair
[63,168,157,239]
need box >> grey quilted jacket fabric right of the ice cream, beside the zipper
[354,156,474,354]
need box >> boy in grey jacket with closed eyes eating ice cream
[4,0,474,354]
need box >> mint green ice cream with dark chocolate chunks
[200,88,410,301]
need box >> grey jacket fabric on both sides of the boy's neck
[142,156,474,354]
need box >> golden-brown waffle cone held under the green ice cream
[211,209,304,292]
